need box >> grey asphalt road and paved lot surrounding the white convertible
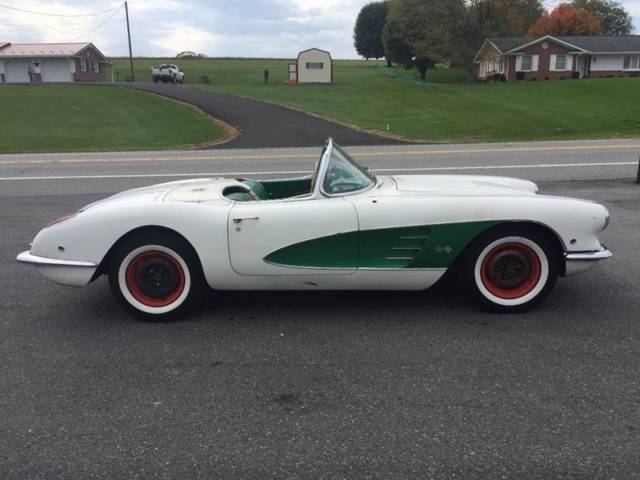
[0,141,640,480]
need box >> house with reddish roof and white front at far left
[0,42,111,83]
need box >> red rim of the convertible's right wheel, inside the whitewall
[480,242,542,299]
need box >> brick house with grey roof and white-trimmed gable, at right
[474,35,640,81]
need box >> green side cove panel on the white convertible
[265,222,498,268]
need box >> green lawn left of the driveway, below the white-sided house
[0,85,225,153]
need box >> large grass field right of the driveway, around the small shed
[113,59,640,142]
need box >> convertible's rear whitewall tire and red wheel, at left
[109,232,205,322]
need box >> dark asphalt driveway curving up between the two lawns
[127,83,405,149]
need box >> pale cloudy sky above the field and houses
[0,0,640,58]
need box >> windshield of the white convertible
[322,144,376,195]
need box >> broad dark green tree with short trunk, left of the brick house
[383,0,464,80]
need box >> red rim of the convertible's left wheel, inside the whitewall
[125,250,185,307]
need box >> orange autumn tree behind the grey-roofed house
[527,3,602,37]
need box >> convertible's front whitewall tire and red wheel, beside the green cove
[460,227,560,312]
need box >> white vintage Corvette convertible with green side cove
[17,139,611,321]
